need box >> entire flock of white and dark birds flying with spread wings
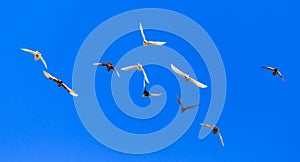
[21,23,285,146]
